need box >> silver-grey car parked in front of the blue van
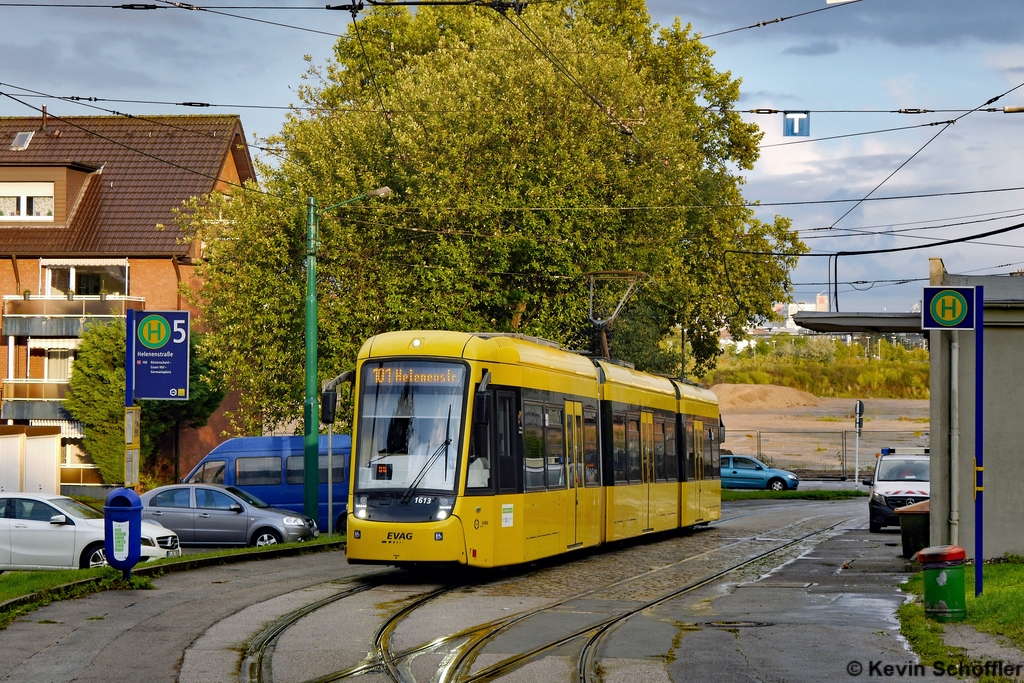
[141,483,319,546]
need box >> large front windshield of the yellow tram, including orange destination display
[355,360,466,492]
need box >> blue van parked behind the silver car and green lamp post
[183,434,352,532]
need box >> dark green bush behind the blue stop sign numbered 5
[63,319,225,483]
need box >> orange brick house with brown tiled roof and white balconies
[0,111,255,486]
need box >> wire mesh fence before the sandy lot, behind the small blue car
[722,429,929,478]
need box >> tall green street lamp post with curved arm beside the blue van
[302,187,391,520]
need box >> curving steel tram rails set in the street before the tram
[249,505,846,683]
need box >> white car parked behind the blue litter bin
[0,494,181,571]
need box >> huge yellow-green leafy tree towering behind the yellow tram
[182,0,805,433]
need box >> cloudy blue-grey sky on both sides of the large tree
[0,0,1024,311]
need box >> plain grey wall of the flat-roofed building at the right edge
[930,301,1024,558]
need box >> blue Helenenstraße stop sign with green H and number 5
[132,310,190,400]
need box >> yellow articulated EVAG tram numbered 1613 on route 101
[347,331,722,567]
